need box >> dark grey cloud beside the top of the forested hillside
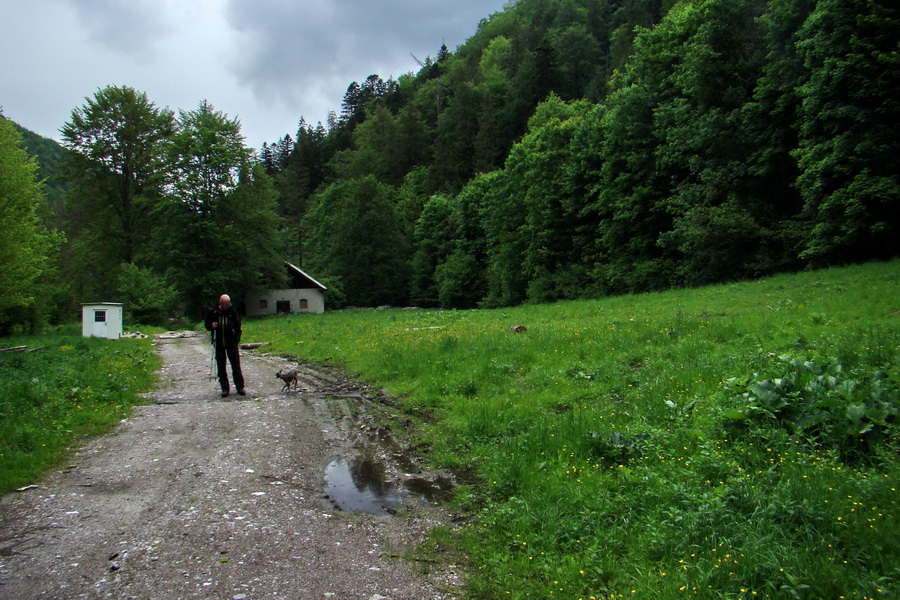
[227,0,504,121]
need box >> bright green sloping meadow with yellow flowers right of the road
[244,261,900,600]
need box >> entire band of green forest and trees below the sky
[0,0,900,332]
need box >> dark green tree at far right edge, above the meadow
[794,0,900,264]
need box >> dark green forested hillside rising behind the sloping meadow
[262,0,900,307]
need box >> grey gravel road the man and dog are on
[0,334,459,600]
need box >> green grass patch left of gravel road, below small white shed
[0,330,159,493]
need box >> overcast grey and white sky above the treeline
[0,0,506,149]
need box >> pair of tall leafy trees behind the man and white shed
[53,86,283,319]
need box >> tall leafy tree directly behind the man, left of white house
[155,101,283,315]
